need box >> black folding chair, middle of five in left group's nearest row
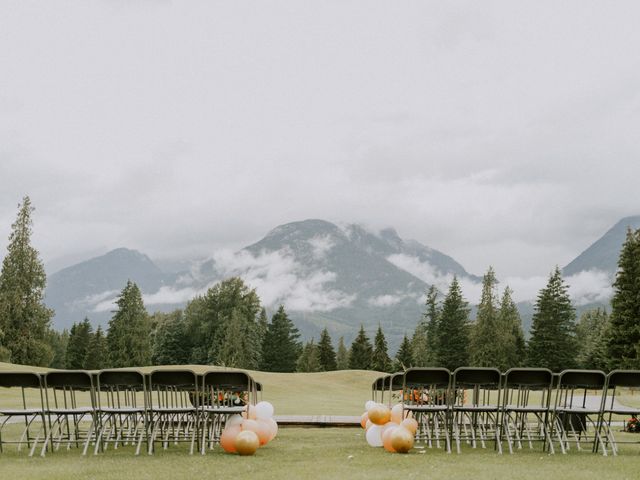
[94,370,149,455]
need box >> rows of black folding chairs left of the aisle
[0,369,262,456]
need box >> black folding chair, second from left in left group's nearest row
[40,370,97,456]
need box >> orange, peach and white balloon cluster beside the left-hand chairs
[220,402,278,455]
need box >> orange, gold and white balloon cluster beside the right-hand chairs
[360,400,418,453]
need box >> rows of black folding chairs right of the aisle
[372,367,640,455]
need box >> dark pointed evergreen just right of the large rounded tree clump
[262,305,301,372]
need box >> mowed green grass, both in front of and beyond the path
[0,363,640,480]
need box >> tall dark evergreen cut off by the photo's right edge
[607,229,640,369]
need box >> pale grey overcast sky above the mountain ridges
[0,0,640,277]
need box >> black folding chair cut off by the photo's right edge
[600,370,640,455]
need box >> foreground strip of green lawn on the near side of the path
[0,428,640,480]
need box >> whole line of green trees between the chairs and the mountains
[0,197,640,372]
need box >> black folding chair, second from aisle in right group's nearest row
[451,367,502,453]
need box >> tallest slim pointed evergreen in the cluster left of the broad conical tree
[471,267,502,367]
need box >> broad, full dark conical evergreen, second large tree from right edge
[528,267,576,372]
